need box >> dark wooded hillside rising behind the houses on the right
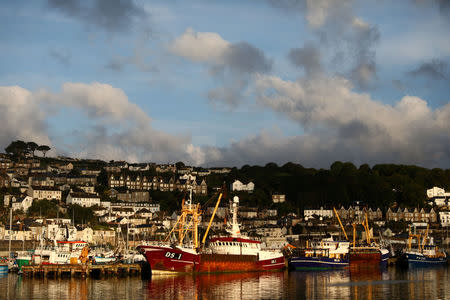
[211,162,450,212]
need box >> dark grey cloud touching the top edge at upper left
[48,0,149,32]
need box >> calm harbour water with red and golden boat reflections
[0,268,450,300]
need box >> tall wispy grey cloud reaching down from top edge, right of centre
[269,0,380,90]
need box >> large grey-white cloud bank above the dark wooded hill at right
[204,75,450,167]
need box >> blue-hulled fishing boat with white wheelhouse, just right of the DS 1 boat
[288,237,350,270]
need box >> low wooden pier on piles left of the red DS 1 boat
[22,264,142,277]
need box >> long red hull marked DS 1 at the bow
[140,246,285,273]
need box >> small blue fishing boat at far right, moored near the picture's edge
[401,225,448,267]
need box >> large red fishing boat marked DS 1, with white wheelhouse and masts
[138,192,285,274]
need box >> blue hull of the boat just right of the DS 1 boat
[288,256,350,270]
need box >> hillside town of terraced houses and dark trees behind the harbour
[0,141,450,252]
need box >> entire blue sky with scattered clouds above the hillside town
[0,0,450,168]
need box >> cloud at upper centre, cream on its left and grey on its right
[168,28,273,107]
